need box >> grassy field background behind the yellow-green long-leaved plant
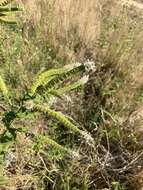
[0,0,143,190]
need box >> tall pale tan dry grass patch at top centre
[18,0,101,58]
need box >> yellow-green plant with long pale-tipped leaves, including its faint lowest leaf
[0,60,93,189]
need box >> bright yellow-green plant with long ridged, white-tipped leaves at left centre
[0,63,90,158]
